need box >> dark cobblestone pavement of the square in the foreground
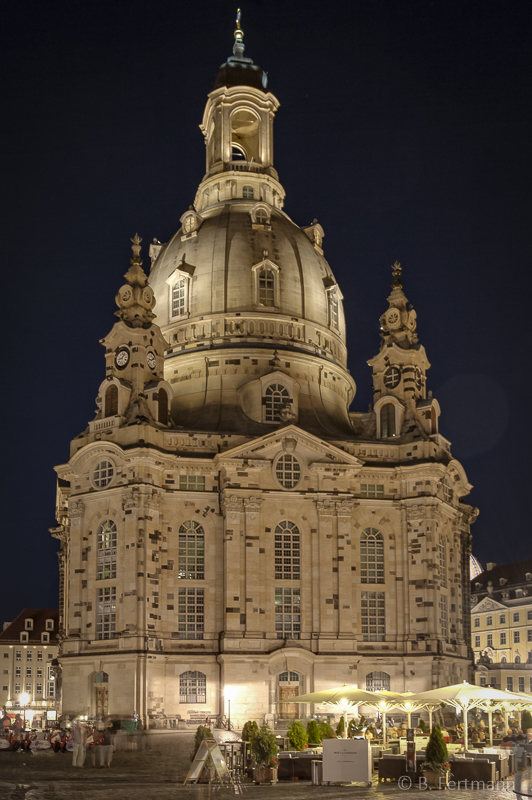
[0,732,532,800]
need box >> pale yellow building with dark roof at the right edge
[471,559,532,693]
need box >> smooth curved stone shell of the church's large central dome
[150,200,346,365]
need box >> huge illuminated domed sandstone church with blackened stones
[53,17,477,724]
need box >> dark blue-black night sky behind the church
[0,0,532,624]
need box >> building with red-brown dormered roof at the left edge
[0,608,59,727]
